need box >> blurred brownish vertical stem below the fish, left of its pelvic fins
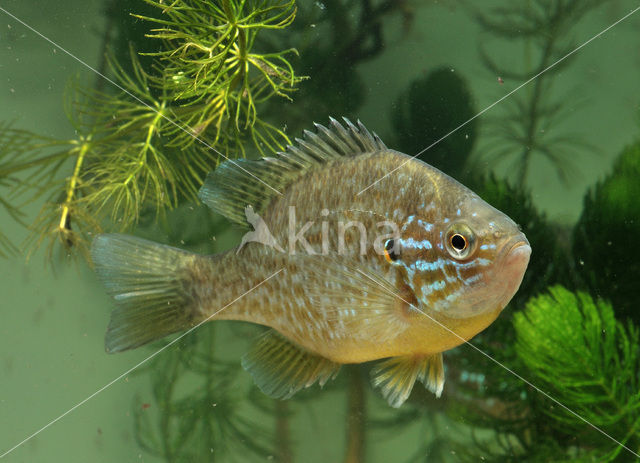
[344,366,367,463]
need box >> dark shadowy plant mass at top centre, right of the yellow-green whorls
[278,0,415,132]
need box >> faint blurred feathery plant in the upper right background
[473,0,605,184]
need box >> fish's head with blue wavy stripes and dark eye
[395,191,531,318]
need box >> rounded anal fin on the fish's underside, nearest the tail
[242,330,340,399]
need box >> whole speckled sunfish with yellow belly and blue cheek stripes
[91,118,531,407]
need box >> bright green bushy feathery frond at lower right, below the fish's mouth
[514,286,640,461]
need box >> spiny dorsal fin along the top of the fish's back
[198,118,387,226]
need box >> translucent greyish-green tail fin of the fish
[91,234,202,353]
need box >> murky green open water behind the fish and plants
[0,0,640,462]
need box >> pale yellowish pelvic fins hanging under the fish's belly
[372,353,444,408]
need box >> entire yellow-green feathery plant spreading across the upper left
[0,0,301,260]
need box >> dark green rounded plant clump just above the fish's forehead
[392,67,477,181]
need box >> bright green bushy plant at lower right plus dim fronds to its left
[453,285,640,462]
